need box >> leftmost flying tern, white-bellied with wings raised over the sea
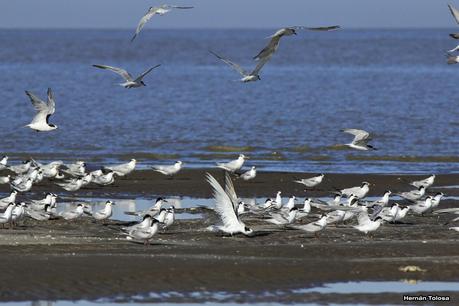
[26,88,57,132]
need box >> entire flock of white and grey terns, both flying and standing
[0,4,459,243]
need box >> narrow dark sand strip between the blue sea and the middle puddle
[0,168,459,198]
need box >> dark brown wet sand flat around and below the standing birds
[0,170,459,305]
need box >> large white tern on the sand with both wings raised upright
[206,172,253,236]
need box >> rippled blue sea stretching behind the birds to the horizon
[0,29,459,173]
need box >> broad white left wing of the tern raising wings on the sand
[206,173,240,227]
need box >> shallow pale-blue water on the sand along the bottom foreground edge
[4,280,459,306]
